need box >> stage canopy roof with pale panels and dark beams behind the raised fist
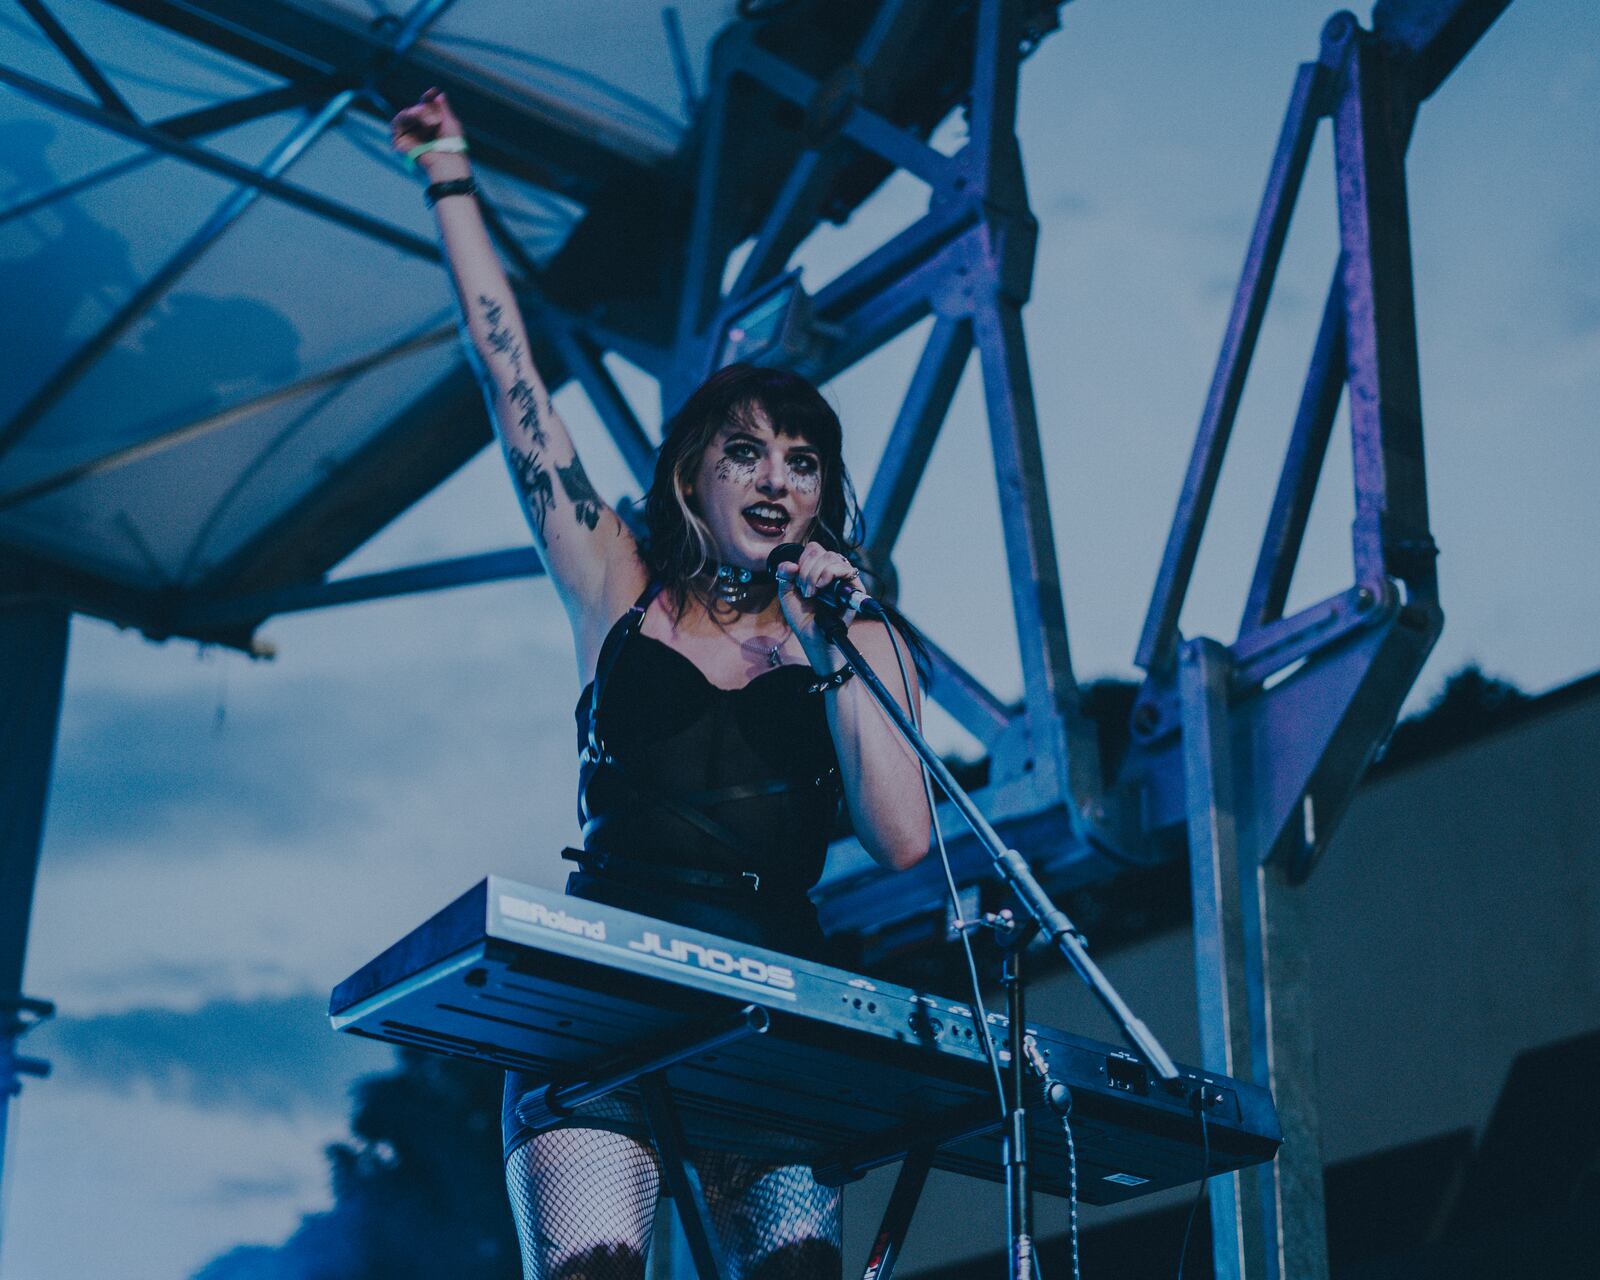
[0,0,998,645]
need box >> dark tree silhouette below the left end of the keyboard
[195,1050,522,1280]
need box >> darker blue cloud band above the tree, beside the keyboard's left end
[40,992,389,1113]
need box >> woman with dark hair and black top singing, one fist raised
[392,91,928,1280]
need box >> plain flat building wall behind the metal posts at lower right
[845,678,1600,1275]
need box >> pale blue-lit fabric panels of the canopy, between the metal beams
[0,0,733,620]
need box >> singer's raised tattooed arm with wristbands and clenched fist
[390,90,645,675]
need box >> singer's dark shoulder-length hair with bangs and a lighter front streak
[643,365,861,610]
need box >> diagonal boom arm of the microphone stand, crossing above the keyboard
[818,606,1178,1082]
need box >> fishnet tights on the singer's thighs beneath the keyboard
[506,1128,843,1280]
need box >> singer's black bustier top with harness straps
[576,589,840,923]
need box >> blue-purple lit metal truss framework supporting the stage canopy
[0,0,1509,1280]
